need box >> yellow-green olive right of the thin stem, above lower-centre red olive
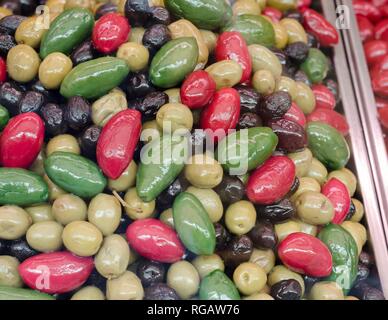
[124,188,156,220]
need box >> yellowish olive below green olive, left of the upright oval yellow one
[51,194,87,225]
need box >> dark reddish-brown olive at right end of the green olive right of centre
[268,119,307,153]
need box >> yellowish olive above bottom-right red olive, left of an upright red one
[295,191,334,226]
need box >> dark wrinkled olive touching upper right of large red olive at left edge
[40,103,67,136]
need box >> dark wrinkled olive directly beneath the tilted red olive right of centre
[252,199,296,224]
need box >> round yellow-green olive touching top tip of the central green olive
[156,103,193,132]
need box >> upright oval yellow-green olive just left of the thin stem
[88,193,121,236]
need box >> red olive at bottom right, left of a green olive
[278,232,333,277]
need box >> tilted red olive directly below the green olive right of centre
[246,156,295,205]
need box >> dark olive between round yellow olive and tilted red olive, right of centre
[214,175,245,204]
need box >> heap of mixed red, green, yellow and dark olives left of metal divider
[0,0,388,300]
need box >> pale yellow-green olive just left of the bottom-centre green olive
[167,261,200,299]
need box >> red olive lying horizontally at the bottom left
[19,251,94,293]
